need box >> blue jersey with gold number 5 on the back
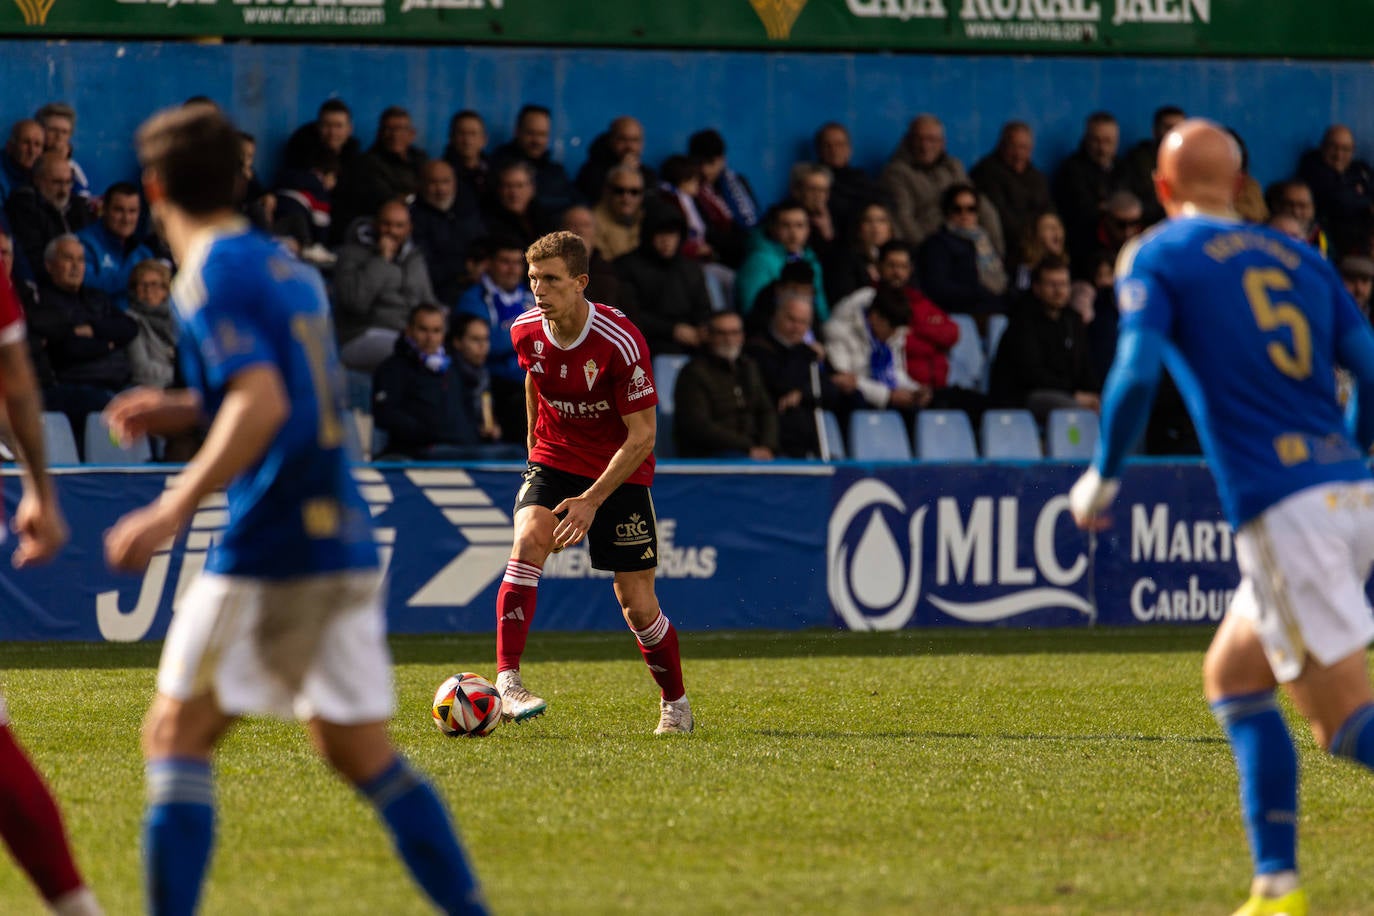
[1117,216,1370,526]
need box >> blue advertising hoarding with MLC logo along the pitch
[0,463,1258,641]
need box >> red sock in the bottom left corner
[0,725,81,901]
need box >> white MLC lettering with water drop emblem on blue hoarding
[826,478,1092,630]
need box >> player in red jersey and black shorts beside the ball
[496,232,692,735]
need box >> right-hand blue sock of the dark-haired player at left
[357,757,486,916]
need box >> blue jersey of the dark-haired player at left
[172,224,378,578]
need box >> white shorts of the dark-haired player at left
[158,570,396,725]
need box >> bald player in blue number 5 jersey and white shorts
[1069,121,1374,916]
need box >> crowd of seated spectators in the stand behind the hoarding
[0,99,1374,460]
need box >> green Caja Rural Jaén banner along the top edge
[0,0,1374,58]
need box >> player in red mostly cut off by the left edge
[0,271,100,916]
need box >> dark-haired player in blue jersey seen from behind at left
[104,106,485,916]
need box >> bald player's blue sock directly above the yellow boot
[1212,691,1297,875]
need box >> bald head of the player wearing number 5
[1154,118,1241,217]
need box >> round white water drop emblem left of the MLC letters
[826,479,927,630]
